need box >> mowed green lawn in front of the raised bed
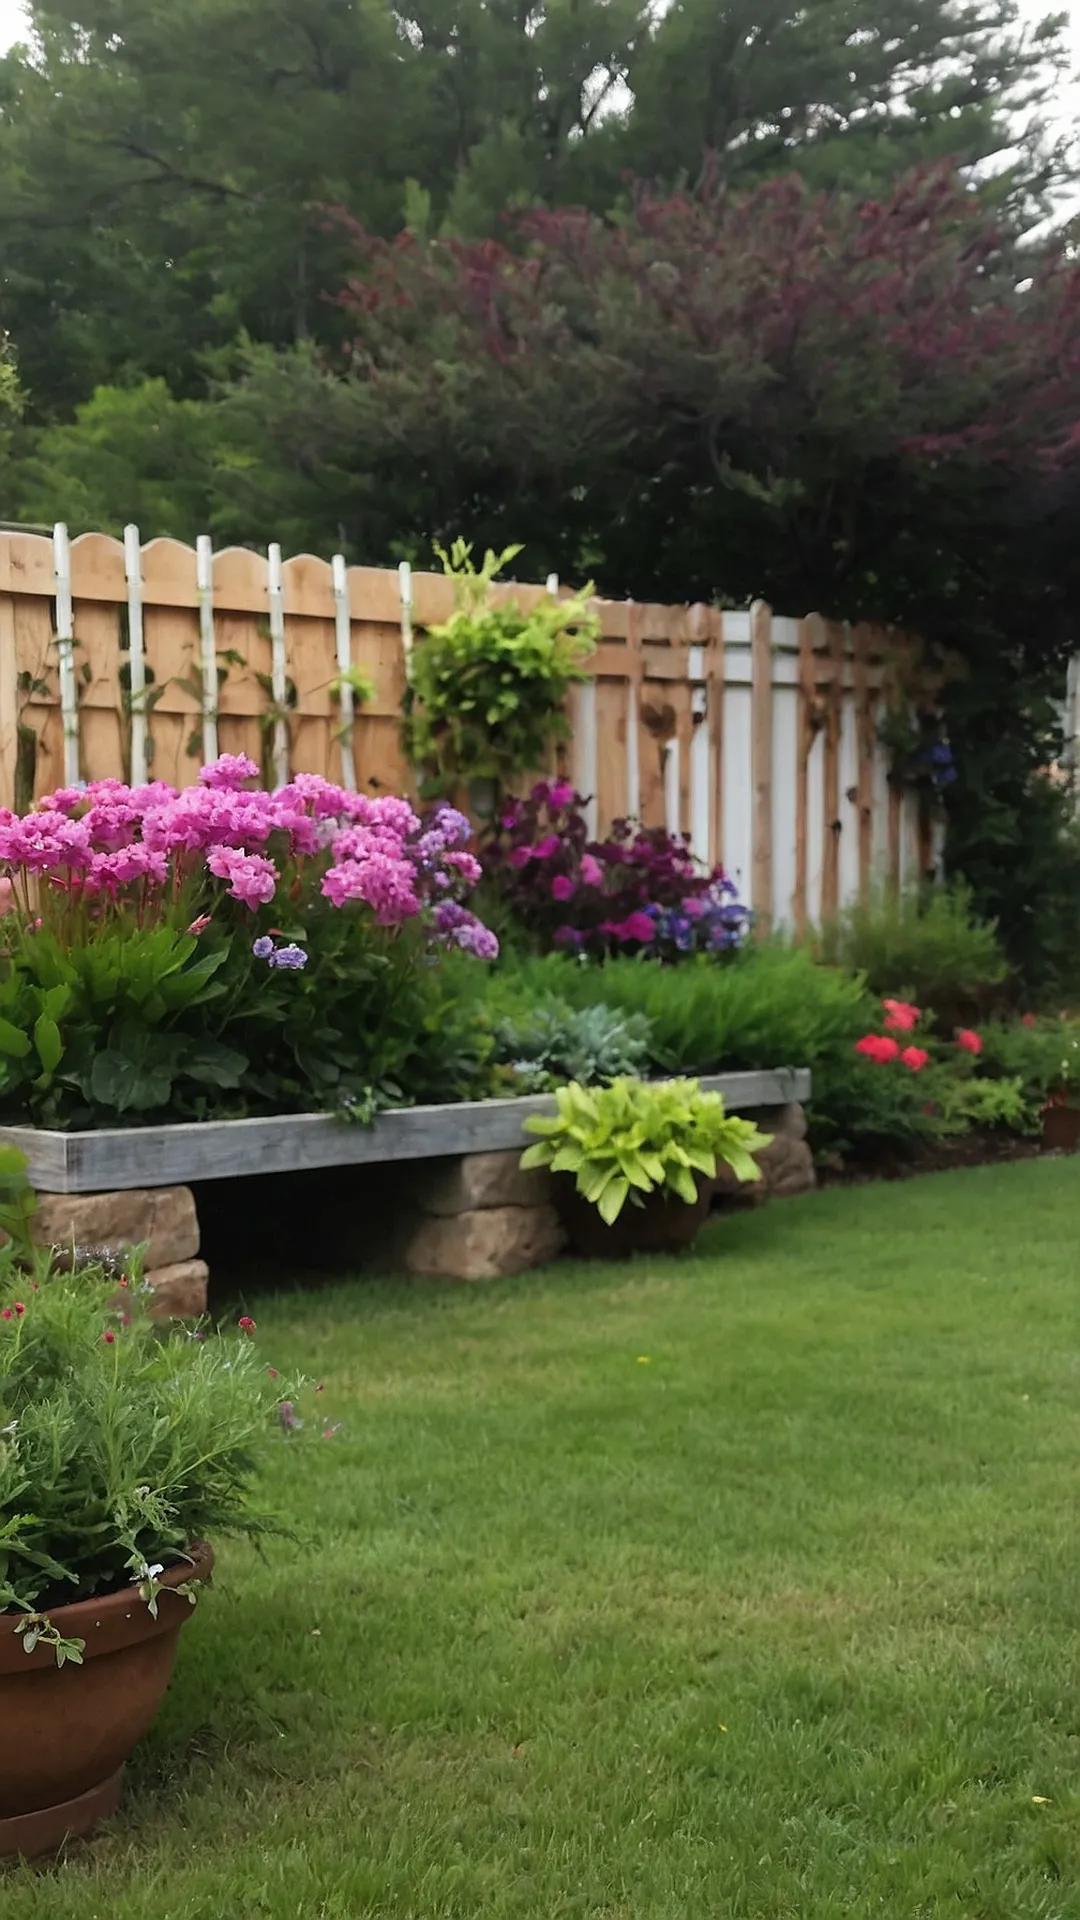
[0,1162,1080,1920]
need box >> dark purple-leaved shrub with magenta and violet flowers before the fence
[482,780,749,960]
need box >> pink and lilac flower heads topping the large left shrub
[0,753,498,952]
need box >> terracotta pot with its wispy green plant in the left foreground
[0,1198,303,1859]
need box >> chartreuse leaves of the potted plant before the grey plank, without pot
[521,1079,769,1225]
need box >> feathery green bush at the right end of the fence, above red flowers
[821,887,1009,1025]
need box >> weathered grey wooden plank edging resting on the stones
[0,1068,811,1194]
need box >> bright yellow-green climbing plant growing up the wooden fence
[404,540,600,797]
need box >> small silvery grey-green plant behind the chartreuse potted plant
[492,998,651,1092]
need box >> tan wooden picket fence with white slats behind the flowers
[0,528,936,929]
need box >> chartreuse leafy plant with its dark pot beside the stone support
[521,1079,769,1260]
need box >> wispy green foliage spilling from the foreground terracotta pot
[0,1248,296,1615]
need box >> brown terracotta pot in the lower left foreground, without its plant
[0,1546,213,1860]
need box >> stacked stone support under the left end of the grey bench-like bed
[35,1187,209,1319]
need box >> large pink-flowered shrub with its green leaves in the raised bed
[0,755,498,1125]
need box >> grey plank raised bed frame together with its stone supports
[0,1068,813,1290]
